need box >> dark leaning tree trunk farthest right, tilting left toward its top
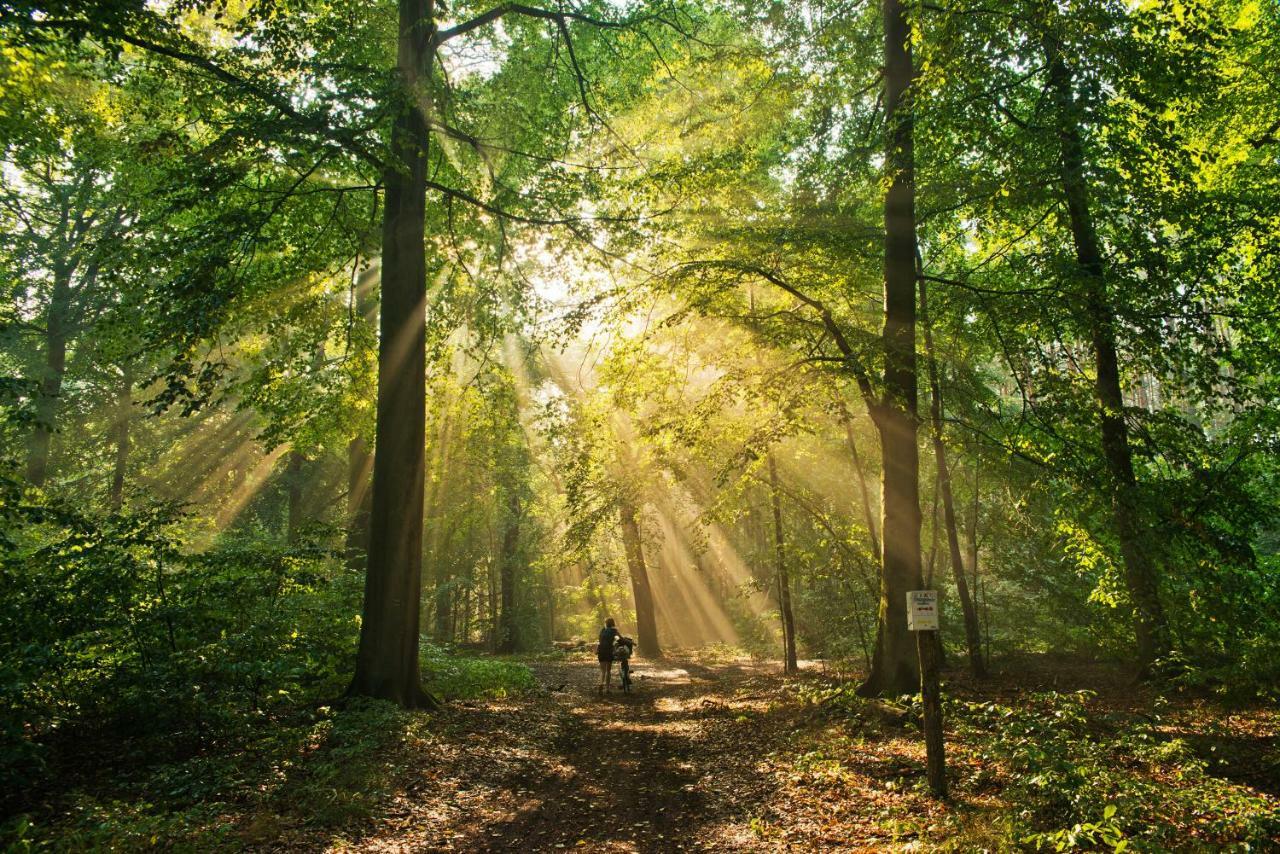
[1043,31,1172,673]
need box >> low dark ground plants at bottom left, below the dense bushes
[0,699,430,850]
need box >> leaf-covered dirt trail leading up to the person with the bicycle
[314,661,836,851]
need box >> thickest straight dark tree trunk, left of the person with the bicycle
[349,0,435,708]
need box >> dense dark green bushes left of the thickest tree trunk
[0,490,360,791]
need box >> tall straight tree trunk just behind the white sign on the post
[859,0,923,695]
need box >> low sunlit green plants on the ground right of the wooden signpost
[947,691,1280,850]
